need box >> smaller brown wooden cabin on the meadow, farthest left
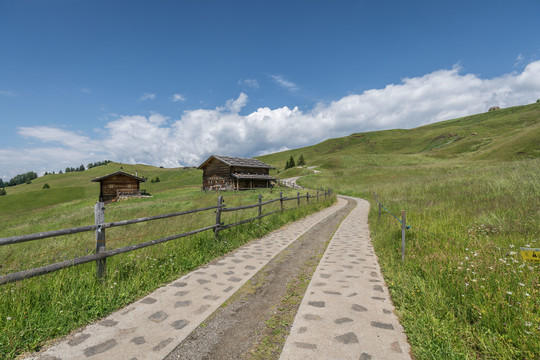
[92,171,146,202]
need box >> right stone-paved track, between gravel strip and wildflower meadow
[280,198,411,360]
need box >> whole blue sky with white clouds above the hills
[0,0,540,180]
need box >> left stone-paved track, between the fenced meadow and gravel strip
[30,199,347,360]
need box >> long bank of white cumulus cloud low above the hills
[0,61,540,179]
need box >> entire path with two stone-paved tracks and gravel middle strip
[27,196,411,360]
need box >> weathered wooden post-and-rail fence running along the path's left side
[0,189,332,285]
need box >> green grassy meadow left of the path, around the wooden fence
[0,163,335,359]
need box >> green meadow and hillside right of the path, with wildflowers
[261,103,540,359]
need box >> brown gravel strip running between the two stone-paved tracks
[166,200,356,360]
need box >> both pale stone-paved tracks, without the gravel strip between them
[31,197,410,360]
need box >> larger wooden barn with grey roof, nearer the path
[198,155,276,190]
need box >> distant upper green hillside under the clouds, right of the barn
[259,103,540,170]
